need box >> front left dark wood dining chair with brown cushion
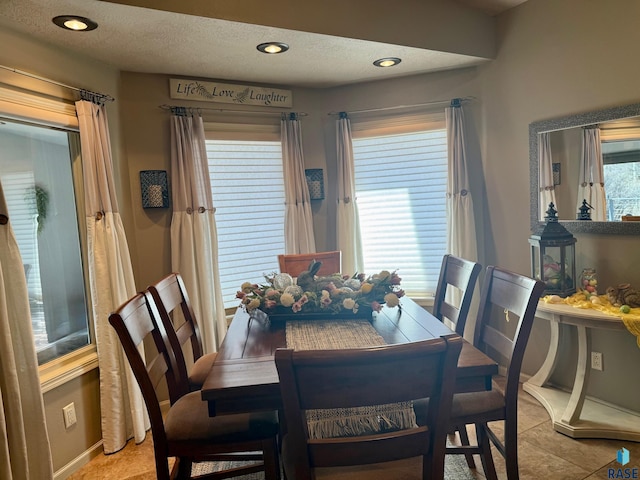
[109,292,280,480]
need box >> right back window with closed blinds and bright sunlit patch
[352,116,447,297]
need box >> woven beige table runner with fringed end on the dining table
[286,320,417,438]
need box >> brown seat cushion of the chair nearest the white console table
[413,390,505,425]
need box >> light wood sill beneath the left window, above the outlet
[39,345,98,393]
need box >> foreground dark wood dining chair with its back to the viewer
[275,334,462,480]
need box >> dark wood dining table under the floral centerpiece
[201,296,498,416]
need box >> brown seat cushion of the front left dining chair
[164,392,278,442]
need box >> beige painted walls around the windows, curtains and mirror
[0,0,640,469]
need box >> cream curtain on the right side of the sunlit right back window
[445,99,478,341]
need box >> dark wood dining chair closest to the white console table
[414,266,545,480]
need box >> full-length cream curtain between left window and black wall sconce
[76,100,149,453]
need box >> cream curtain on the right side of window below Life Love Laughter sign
[280,113,316,254]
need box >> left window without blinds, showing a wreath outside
[0,119,91,365]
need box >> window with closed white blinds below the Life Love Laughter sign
[206,124,285,309]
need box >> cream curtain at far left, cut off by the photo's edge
[0,184,53,480]
